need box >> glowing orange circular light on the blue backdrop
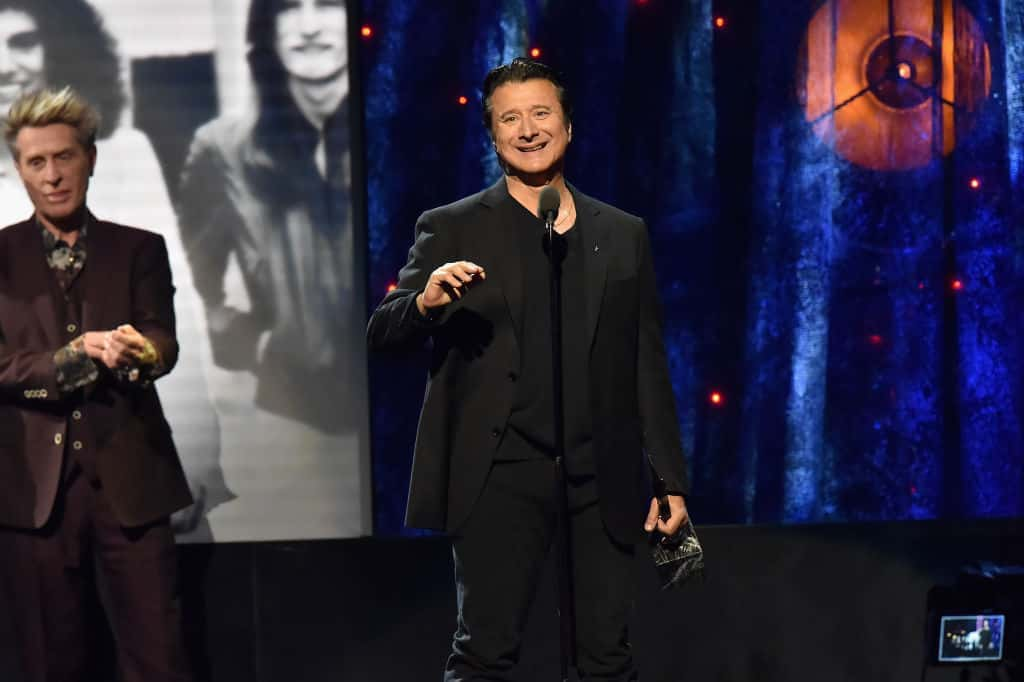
[798,0,992,171]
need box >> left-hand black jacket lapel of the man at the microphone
[470,177,523,339]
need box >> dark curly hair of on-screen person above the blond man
[0,0,126,138]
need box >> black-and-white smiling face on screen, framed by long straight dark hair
[274,0,348,81]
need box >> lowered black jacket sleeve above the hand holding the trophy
[637,223,689,495]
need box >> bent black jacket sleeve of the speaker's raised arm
[367,212,458,350]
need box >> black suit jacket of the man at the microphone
[367,178,687,543]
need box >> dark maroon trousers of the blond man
[0,456,193,682]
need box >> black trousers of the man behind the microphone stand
[444,459,643,682]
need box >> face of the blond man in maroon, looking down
[14,123,96,225]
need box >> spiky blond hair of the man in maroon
[3,87,99,159]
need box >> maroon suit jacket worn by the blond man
[0,219,191,528]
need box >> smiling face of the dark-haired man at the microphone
[490,78,572,184]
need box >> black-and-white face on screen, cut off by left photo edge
[0,9,44,116]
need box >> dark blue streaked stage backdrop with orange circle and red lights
[362,0,1024,535]
